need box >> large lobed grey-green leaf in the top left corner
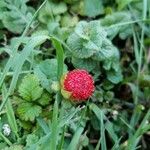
[0,0,34,33]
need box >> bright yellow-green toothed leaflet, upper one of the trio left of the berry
[19,74,43,101]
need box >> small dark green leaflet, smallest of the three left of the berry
[38,92,52,106]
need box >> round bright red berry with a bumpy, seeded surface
[63,69,95,101]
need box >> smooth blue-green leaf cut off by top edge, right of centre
[84,0,104,17]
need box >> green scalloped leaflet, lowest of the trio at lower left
[17,103,42,121]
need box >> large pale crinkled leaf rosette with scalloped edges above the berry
[67,21,107,58]
